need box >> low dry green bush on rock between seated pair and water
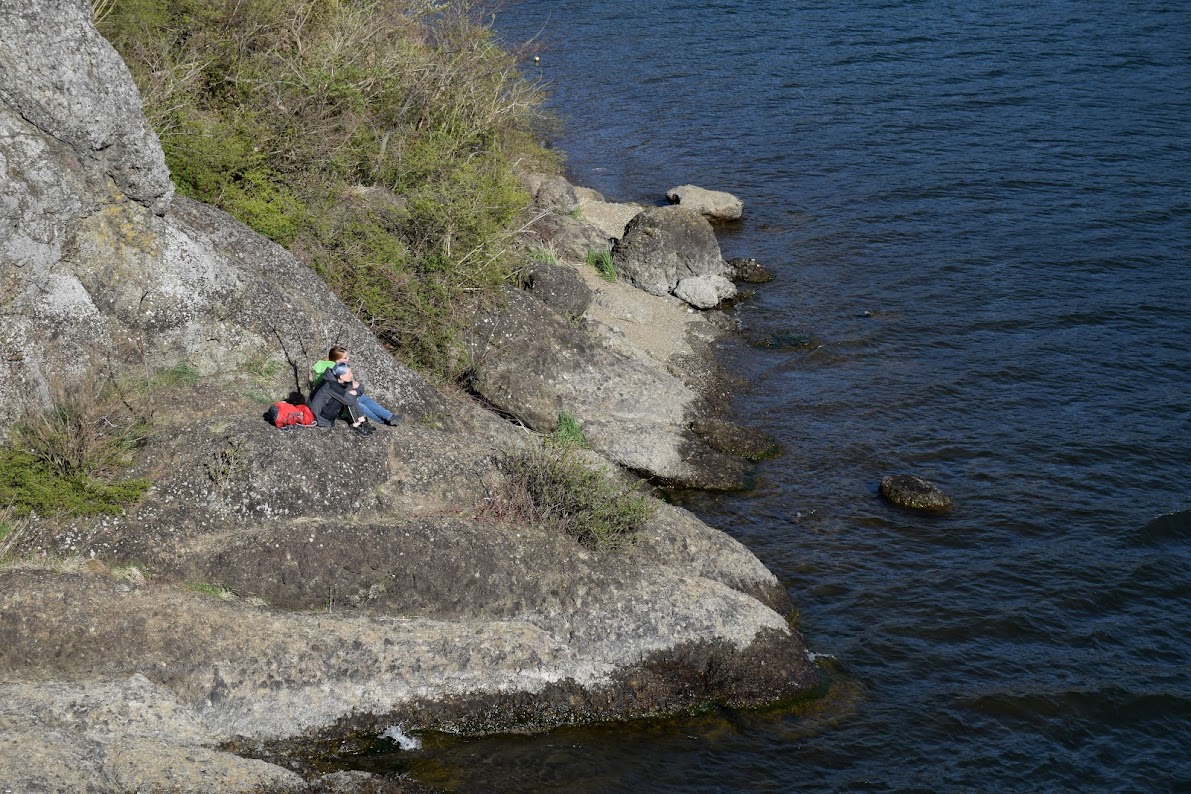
[485,440,654,550]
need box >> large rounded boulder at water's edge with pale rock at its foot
[612,206,736,308]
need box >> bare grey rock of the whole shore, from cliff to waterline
[0,0,819,792]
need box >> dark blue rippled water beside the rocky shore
[390,0,1191,792]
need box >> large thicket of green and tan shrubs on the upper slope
[96,0,557,377]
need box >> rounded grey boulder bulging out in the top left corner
[0,0,174,217]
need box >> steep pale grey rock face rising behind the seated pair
[0,0,438,417]
